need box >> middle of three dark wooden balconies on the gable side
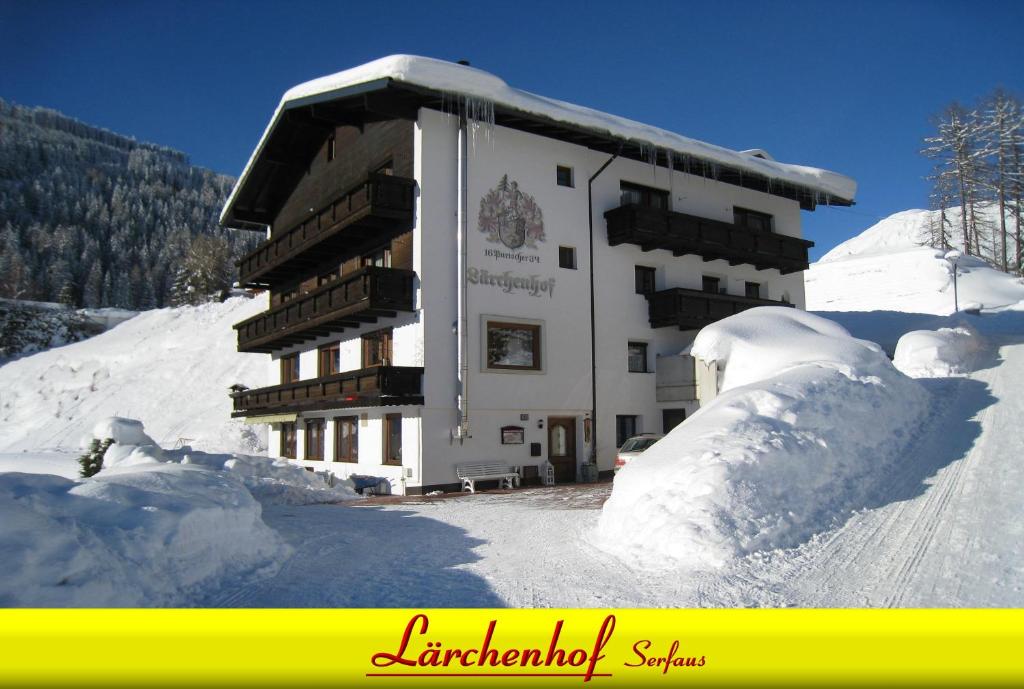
[234,266,416,352]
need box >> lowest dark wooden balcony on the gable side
[230,367,423,417]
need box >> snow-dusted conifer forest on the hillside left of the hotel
[0,99,256,310]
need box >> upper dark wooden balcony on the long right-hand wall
[604,204,814,274]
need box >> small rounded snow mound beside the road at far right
[893,326,982,378]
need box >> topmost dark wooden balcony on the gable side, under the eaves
[238,174,416,287]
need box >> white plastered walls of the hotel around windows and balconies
[270,107,804,492]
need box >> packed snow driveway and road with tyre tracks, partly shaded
[196,338,1024,607]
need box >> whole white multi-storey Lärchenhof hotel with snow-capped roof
[221,55,856,493]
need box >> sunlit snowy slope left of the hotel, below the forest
[0,297,267,454]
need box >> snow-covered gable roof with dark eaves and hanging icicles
[220,55,857,224]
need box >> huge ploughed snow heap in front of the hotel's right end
[595,307,928,567]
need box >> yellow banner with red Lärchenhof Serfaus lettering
[0,609,1024,689]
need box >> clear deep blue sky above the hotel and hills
[0,0,1024,257]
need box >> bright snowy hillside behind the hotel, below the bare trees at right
[805,205,1024,313]
